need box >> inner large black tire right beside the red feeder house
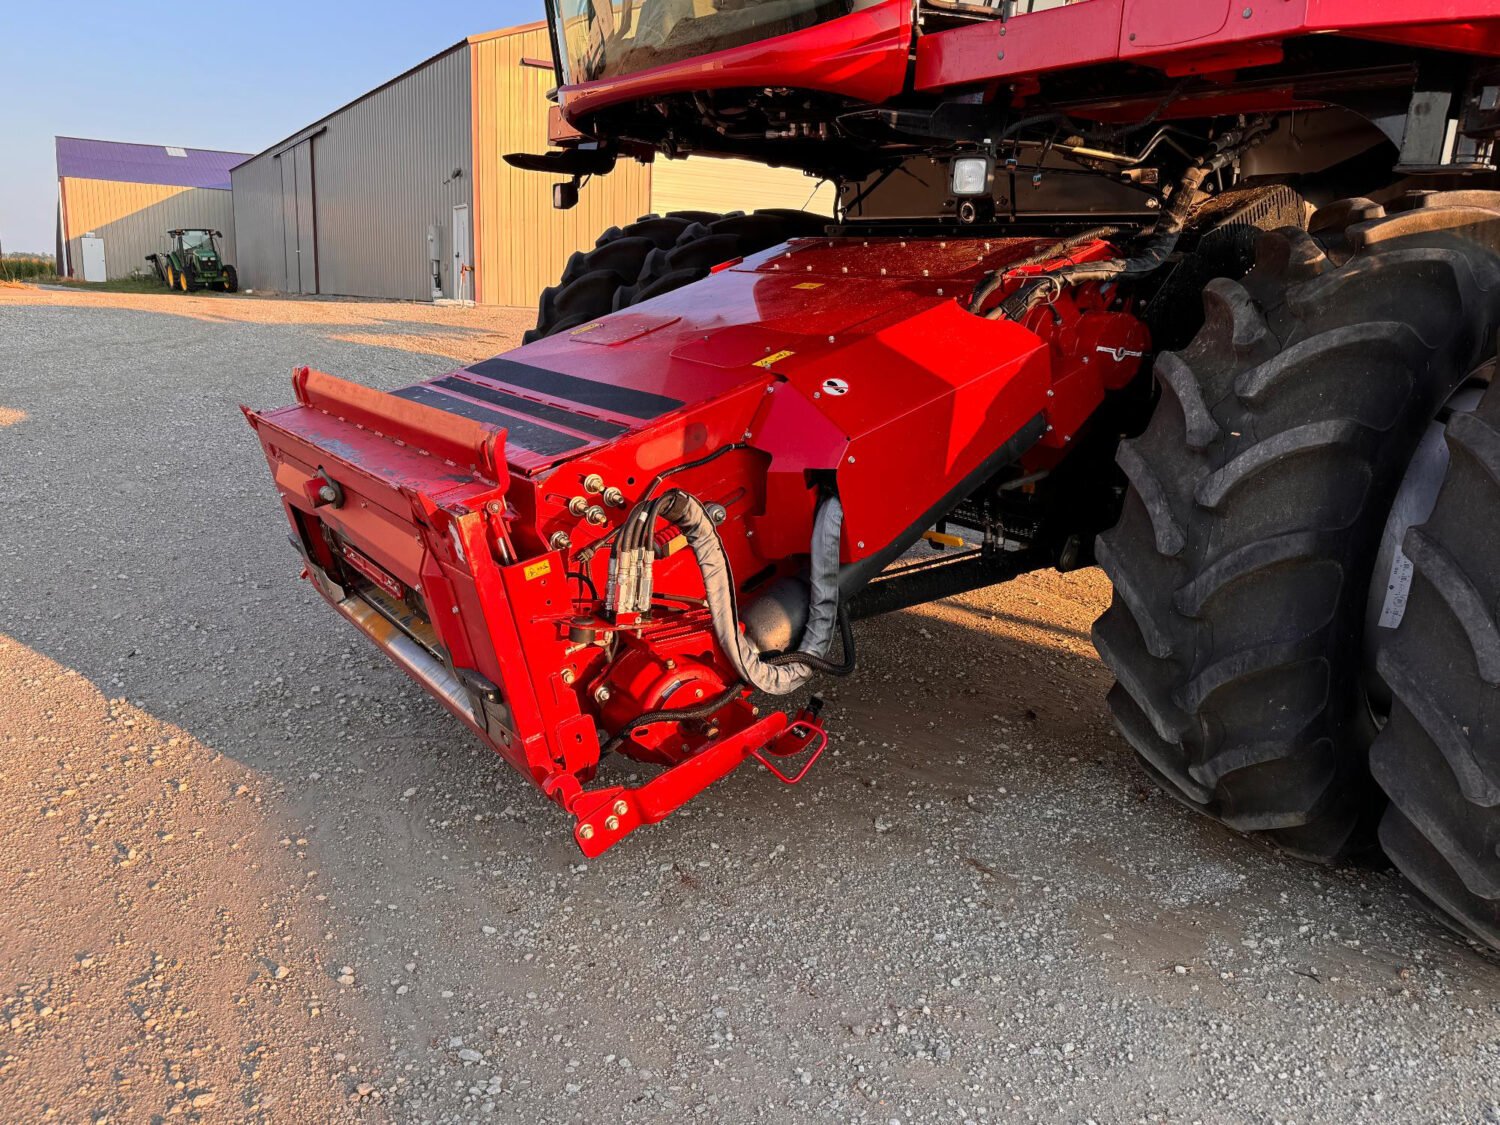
[1094,194,1500,863]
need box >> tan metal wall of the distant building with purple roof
[62,177,236,279]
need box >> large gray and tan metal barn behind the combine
[231,24,831,305]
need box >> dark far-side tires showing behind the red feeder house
[524,210,828,344]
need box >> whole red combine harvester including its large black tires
[248,0,1500,945]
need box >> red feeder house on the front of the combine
[249,239,1148,854]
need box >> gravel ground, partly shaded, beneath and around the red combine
[0,288,1500,1125]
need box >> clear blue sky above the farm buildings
[0,0,543,252]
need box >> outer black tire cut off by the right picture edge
[1370,372,1500,950]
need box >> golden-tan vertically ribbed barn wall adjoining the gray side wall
[473,29,651,305]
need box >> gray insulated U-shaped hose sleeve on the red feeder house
[662,492,843,696]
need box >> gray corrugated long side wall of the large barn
[231,44,474,300]
